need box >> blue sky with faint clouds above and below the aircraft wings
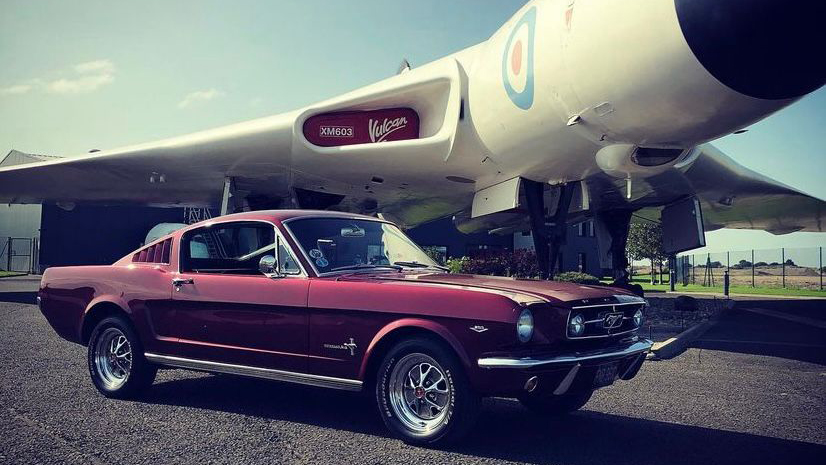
[0,0,826,251]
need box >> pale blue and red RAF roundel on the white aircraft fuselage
[502,7,536,110]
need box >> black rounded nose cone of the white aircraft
[674,0,826,100]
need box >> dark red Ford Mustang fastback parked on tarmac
[38,210,651,443]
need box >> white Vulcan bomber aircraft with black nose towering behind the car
[0,0,826,278]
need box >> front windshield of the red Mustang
[286,218,441,273]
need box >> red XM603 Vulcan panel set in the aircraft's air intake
[304,108,419,147]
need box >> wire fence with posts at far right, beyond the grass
[676,247,824,290]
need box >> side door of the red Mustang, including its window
[171,221,309,372]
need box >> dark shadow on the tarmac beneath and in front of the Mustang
[142,375,826,465]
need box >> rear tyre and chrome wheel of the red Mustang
[87,316,158,399]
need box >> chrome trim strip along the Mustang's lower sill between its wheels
[143,352,362,391]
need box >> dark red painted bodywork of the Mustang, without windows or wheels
[39,210,644,395]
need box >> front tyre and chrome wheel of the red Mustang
[376,338,481,445]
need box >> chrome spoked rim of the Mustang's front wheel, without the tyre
[388,353,453,433]
